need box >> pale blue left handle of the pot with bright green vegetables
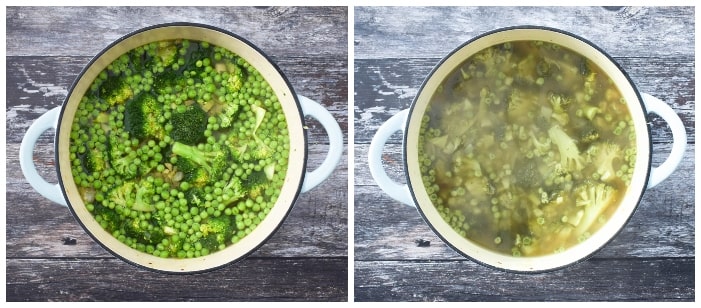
[19,106,68,206]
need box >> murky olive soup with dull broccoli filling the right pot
[418,41,636,256]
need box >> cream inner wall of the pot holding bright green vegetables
[56,24,306,273]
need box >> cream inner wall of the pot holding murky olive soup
[404,27,650,272]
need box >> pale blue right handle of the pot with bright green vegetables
[297,95,343,192]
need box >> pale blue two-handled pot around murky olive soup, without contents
[368,26,686,273]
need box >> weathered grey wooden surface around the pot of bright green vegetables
[3,7,348,301]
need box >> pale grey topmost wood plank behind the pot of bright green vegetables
[6,6,348,57]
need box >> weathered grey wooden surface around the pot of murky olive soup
[353,7,695,301]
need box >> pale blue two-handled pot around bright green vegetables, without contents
[20,23,343,273]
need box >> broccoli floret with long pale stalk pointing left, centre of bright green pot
[172,142,229,179]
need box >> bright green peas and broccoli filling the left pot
[70,40,289,258]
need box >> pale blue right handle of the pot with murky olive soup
[641,93,686,188]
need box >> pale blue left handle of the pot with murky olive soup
[368,109,415,207]
